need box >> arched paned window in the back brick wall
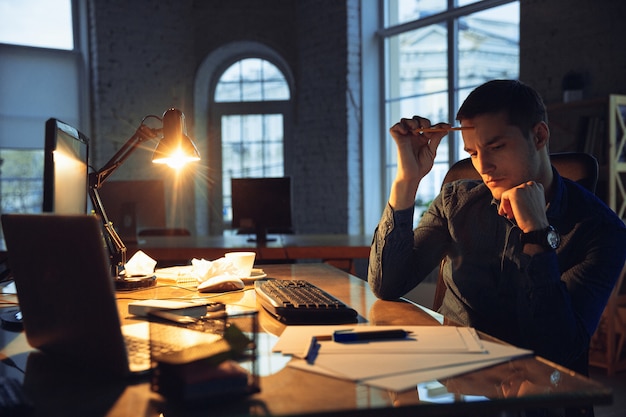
[212,58,290,228]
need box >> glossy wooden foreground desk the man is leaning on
[0,264,612,417]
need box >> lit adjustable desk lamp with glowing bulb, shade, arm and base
[89,108,200,290]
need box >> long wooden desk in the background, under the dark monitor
[126,234,372,273]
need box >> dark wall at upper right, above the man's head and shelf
[520,0,626,103]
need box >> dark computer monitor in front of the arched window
[231,177,292,243]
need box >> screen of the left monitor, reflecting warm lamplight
[43,119,89,214]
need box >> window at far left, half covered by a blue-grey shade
[0,0,87,221]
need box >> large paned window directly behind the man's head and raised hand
[379,0,519,222]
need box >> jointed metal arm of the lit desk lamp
[89,123,161,277]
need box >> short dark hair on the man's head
[456,80,548,135]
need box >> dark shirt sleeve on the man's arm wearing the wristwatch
[508,221,626,366]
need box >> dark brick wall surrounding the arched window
[90,0,360,233]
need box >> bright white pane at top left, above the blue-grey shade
[0,0,74,50]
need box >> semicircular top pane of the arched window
[215,58,289,102]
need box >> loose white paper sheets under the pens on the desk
[273,326,532,391]
